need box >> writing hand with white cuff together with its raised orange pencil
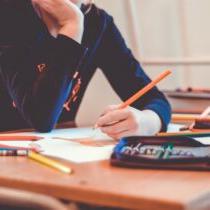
[96,70,171,139]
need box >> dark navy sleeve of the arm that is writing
[98,15,171,131]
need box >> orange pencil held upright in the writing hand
[119,70,171,109]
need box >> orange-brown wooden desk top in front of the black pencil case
[0,157,210,210]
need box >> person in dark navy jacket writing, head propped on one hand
[0,0,170,138]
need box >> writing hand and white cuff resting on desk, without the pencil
[97,106,161,139]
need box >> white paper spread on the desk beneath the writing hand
[1,128,115,163]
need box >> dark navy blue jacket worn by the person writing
[0,0,171,132]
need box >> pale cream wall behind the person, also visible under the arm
[77,0,210,124]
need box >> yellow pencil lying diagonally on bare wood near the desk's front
[28,151,72,174]
